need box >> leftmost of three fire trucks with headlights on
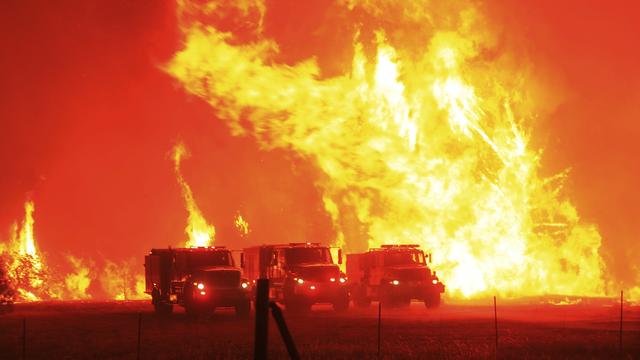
[144,246,251,316]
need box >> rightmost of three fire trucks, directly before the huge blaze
[347,245,445,308]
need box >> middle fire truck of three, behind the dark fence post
[241,243,349,312]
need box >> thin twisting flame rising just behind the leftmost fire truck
[173,143,216,246]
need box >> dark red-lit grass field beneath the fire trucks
[0,301,640,359]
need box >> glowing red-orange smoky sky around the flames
[0,0,640,290]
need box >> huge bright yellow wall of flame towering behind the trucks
[166,0,605,297]
